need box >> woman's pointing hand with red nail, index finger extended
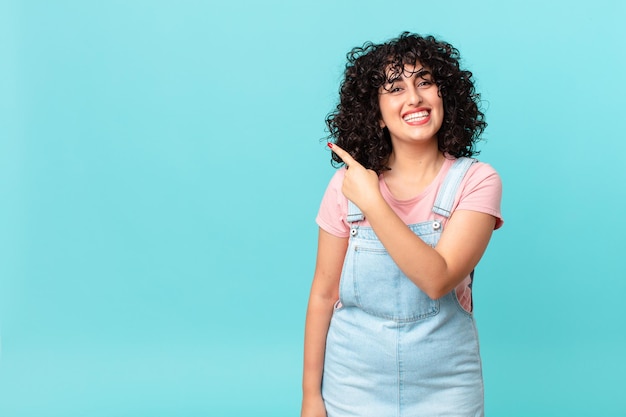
[328,143,382,213]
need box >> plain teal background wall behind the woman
[0,0,626,417]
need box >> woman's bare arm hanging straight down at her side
[302,229,348,417]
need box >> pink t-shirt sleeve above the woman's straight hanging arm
[315,168,350,237]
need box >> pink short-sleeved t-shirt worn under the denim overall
[316,159,503,311]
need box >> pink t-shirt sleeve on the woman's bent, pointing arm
[456,162,504,229]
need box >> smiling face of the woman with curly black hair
[378,62,443,144]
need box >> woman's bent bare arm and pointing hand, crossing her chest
[332,145,496,299]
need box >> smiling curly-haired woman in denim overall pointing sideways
[302,32,502,417]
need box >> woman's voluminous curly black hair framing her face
[326,32,487,174]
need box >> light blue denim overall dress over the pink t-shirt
[322,158,484,417]
